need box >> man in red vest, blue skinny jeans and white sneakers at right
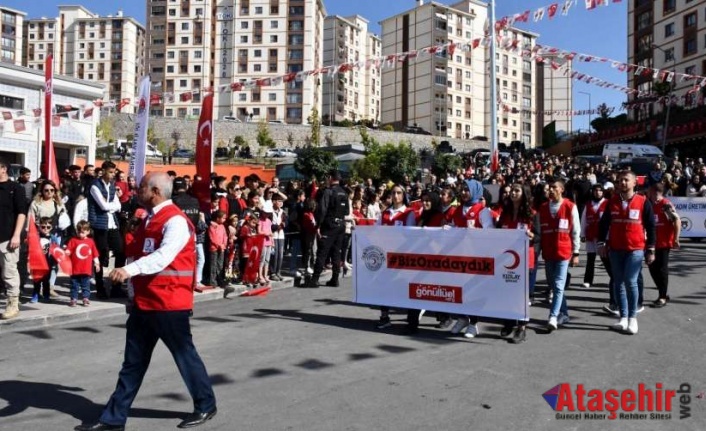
[598,171,655,334]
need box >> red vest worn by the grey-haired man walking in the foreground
[126,204,196,311]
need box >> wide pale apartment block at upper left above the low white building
[23,6,145,113]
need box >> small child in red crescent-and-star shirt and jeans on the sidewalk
[66,220,100,307]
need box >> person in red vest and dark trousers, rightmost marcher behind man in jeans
[649,183,681,308]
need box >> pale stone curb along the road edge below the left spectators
[0,277,294,335]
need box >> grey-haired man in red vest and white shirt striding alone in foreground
[75,173,216,431]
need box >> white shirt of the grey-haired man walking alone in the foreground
[125,200,190,277]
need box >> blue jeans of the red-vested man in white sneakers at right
[610,250,645,318]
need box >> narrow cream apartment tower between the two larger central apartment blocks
[321,15,381,124]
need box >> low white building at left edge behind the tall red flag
[0,62,104,179]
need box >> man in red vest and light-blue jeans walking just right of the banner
[539,180,581,332]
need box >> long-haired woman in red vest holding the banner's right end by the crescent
[497,184,539,344]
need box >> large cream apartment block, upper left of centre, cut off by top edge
[147,0,326,124]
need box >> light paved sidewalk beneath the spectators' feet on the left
[0,275,294,335]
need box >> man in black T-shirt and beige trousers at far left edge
[0,158,28,320]
